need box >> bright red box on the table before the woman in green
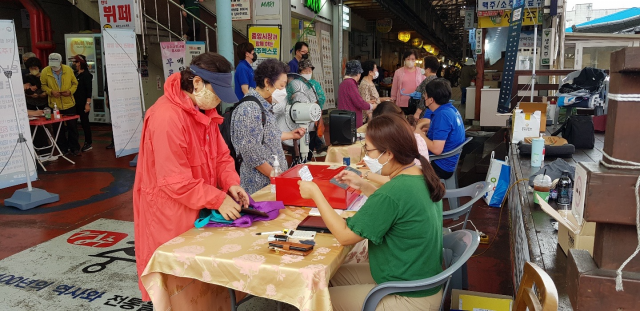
[276,164,360,209]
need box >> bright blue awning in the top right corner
[565,8,640,33]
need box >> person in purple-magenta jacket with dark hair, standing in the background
[338,60,378,127]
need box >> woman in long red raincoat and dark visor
[133,53,249,301]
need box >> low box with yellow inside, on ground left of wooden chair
[451,289,513,311]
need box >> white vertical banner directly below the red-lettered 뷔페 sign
[102,29,143,158]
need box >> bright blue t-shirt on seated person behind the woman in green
[425,103,465,172]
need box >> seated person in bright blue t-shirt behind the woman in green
[416,78,466,179]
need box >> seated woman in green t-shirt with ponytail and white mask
[300,115,445,311]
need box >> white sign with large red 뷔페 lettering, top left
[98,0,140,34]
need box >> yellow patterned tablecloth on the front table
[141,188,351,311]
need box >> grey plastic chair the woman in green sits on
[362,230,480,311]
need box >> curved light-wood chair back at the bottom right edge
[513,262,558,311]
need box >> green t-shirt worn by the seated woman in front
[347,175,442,297]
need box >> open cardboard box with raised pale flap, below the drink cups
[534,194,596,256]
